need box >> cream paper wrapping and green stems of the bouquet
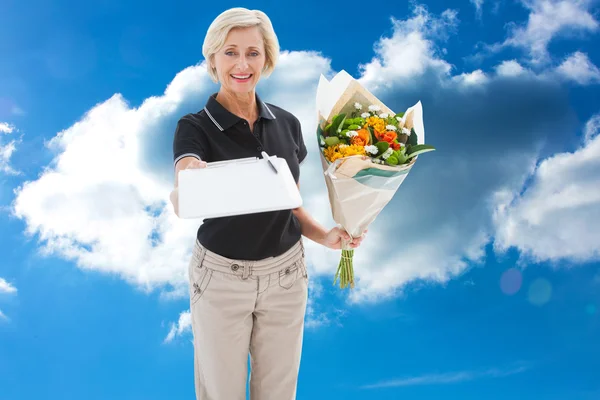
[316,71,432,287]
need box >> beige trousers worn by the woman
[189,240,308,400]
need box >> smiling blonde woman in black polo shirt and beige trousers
[173,8,362,400]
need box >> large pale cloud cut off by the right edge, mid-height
[494,114,600,262]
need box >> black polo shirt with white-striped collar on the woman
[173,93,307,260]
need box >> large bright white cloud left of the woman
[14,66,216,293]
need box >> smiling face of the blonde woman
[213,26,266,94]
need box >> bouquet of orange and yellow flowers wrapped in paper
[317,71,435,288]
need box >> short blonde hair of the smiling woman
[202,7,279,83]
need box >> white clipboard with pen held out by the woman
[178,152,302,219]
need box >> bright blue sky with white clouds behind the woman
[0,0,600,400]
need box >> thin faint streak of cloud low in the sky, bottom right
[362,364,529,389]
